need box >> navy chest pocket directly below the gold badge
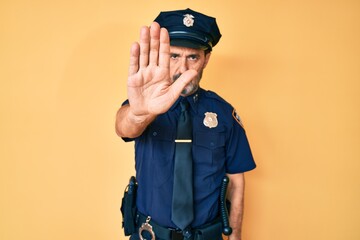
[193,132,226,174]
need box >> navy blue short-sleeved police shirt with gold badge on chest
[124,89,256,228]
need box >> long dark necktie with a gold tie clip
[171,99,194,230]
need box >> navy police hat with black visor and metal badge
[154,8,221,51]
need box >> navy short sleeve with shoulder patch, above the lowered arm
[226,113,256,174]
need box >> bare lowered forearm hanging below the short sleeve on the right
[227,174,245,240]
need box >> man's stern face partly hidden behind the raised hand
[170,46,211,96]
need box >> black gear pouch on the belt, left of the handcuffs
[120,176,137,236]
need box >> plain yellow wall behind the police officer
[0,0,360,240]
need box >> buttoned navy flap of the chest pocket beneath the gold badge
[194,132,225,149]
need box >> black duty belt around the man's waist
[137,213,222,240]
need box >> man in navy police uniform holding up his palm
[116,9,255,240]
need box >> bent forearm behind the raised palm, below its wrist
[115,104,156,138]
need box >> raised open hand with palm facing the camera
[127,22,197,121]
